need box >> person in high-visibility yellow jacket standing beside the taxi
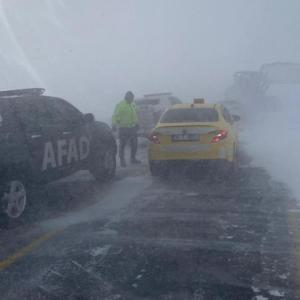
[112,91,141,167]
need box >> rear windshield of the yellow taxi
[160,108,219,123]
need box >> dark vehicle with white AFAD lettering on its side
[0,89,117,223]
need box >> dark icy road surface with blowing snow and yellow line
[0,150,300,300]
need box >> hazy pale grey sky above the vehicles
[0,0,300,118]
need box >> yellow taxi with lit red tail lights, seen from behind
[148,99,240,176]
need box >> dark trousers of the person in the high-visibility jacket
[119,127,137,160]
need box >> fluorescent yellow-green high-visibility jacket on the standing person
[112,100,138,128]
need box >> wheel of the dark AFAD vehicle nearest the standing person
[90,148,117,182]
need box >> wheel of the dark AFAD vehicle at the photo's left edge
[0,180,27,225]
